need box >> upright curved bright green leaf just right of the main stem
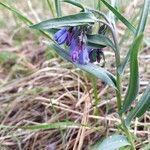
[122,33,144,112]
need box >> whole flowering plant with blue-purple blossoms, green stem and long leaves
[31,0,150,150]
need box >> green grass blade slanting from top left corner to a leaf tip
[0,2,33,25]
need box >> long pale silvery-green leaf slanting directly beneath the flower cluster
[47,43,116,89]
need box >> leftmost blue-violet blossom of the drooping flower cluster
[54,27,68,45]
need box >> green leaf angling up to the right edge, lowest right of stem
[125,83,150,126]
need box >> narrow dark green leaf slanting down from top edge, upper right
[101,0,136,33]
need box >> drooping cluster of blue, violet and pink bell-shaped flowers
[54,27,102,65]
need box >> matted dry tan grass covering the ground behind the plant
[0,0,150,150]
